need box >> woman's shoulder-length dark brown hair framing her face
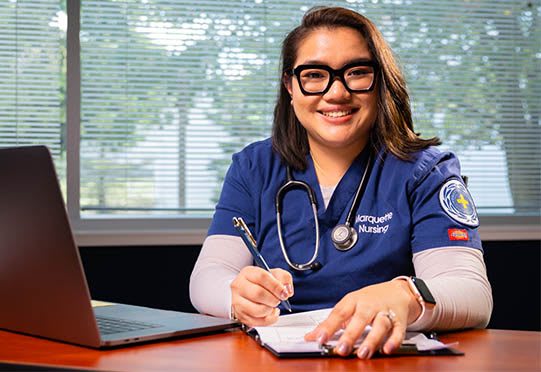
[272,7,441,170]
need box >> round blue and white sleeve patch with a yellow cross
[440,179,479,227]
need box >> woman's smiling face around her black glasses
[286,27,377,154]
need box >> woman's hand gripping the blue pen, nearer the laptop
[231,266,293,327]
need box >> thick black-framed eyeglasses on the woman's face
[289,61,378,95]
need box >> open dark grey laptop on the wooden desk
[0,146,238,348]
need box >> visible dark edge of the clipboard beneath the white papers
[241,324,464,359]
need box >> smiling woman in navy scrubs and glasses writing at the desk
[190,8,492,359]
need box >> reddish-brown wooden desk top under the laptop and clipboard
[0,330,541,372]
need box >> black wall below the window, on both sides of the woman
[80,240,541,331]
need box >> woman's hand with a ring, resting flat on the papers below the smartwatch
[304,280,421,359]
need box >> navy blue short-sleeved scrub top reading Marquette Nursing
[208,139,482,312]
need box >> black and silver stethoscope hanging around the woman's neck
[276,153,372,271]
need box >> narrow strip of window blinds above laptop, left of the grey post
[0,0,66,188]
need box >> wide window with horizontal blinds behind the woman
[0,0,541,244]
